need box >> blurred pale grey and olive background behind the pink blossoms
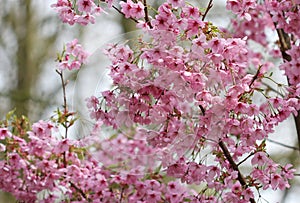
[0,0,300,203]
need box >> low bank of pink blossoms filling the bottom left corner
[0,118,199,203]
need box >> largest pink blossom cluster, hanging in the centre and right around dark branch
[85,1,300,202]
